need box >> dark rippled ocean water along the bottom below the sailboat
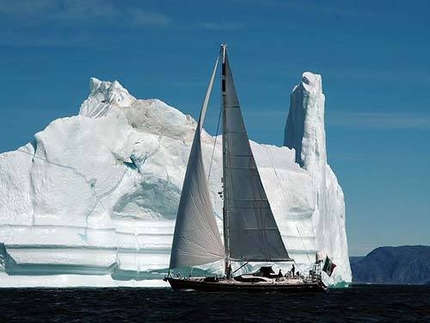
[0,286,430,322]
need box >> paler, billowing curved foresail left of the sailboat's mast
[170,60,224,268]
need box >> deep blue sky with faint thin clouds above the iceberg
[0,0,430,255]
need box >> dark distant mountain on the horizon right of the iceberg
[351,246,430,284]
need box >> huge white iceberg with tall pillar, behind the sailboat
[0,73,351,286]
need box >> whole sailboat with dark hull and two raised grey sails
[164,44,326,292]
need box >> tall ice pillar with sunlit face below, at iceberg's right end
[284,72,351,280]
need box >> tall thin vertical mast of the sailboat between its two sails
[221,43,231,278]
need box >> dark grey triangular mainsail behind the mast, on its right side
[222,53,289,261]
